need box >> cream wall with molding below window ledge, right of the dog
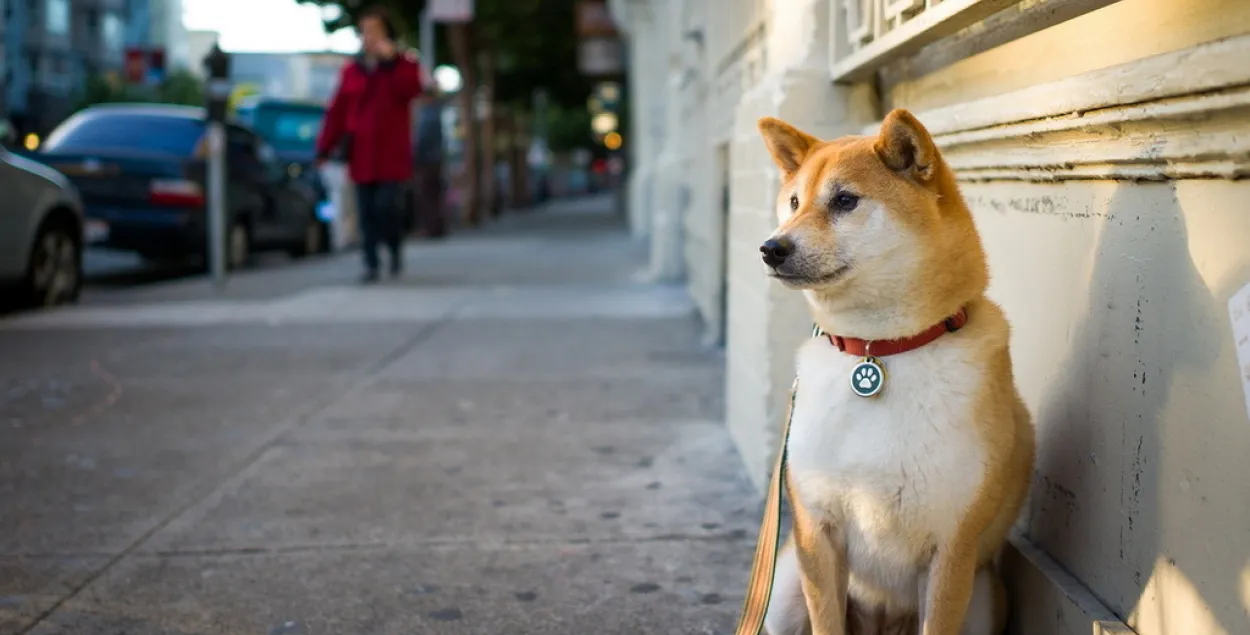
[869,0,1250,635]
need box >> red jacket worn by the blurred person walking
[316,53,421,183]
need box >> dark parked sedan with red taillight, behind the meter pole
[38,104,325,269]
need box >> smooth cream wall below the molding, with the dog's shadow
[965,180,1250,635]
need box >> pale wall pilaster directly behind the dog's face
[725,0,875,489]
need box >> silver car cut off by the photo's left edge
[0,120,83,306]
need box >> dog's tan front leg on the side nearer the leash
[790,496,850,635]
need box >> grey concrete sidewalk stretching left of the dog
[0,199,759,635]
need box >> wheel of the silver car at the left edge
[25,219,83,306]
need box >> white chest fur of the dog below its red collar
[788,336,985,604]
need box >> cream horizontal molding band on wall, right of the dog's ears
[865,36,1250,181]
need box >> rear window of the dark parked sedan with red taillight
[43,111,204,156]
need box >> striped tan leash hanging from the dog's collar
[734,326,824,635]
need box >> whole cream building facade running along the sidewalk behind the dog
[613,0,1250,635]
